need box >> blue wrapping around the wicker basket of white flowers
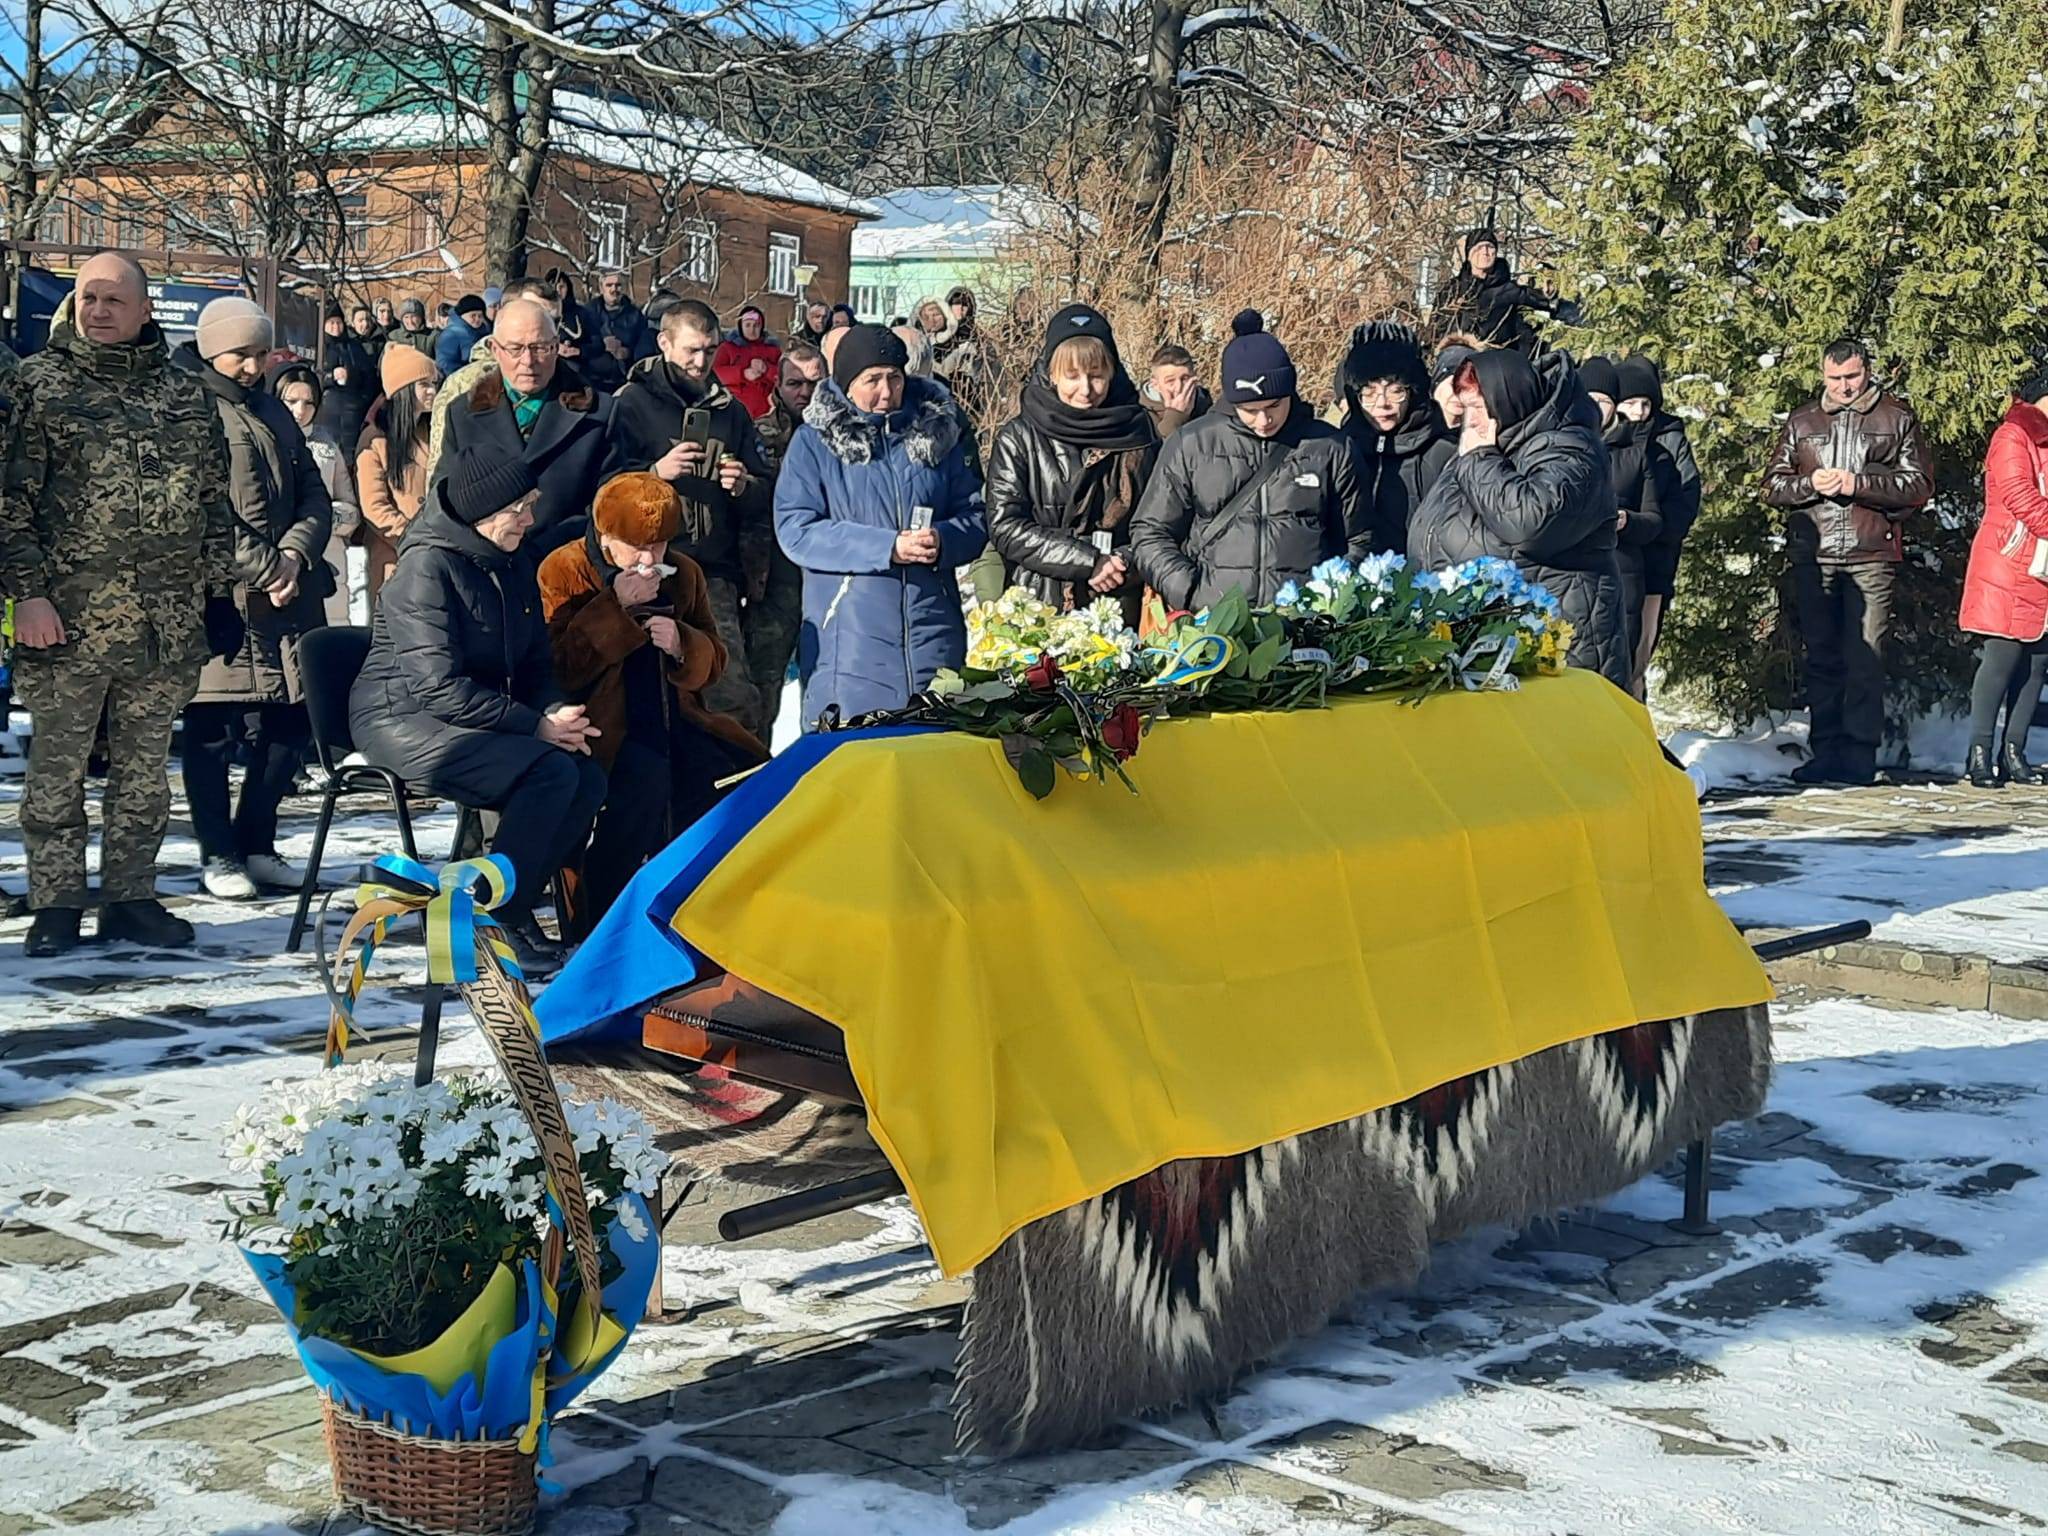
[242,1249,548,1440]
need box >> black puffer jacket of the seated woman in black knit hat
[348,493,561,799]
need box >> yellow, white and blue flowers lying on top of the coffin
[913,555,1571,799]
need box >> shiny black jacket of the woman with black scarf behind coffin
[985,416,1159,608]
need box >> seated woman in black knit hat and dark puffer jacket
[348,449,604,973]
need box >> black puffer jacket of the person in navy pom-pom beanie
[1130,399,1372,608]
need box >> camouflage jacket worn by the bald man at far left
[0,319,248,666]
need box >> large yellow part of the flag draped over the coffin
[674,672,1772,1274]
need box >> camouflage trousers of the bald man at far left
[14,659,199,909]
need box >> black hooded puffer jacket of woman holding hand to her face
[1409,352,1632,688]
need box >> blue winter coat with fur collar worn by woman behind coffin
[774,379,989,725]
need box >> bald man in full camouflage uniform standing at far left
[0,254,260,954]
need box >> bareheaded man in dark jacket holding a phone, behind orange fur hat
[606,299,774,735]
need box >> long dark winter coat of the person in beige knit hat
[172,342,334,705]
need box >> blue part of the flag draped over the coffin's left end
[532,725,930,1044]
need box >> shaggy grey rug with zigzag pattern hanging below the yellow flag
[954,1006,1772,1456]
